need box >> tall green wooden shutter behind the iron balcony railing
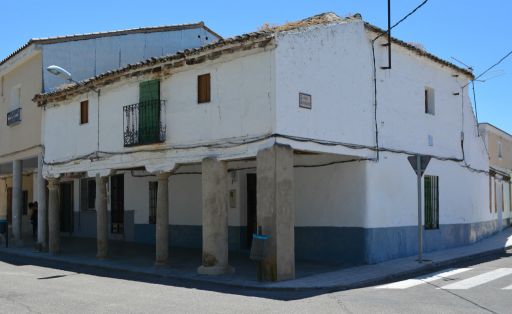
[139,80,160,144]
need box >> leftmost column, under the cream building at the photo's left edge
[12,160,23,245]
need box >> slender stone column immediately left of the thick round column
[155,172,170,265]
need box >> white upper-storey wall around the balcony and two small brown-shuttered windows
[43,52,274,171]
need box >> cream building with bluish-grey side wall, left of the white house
[0,22,220,244]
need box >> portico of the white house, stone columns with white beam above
[40,139,368,281]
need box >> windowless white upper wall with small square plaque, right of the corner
[275,22,375,154]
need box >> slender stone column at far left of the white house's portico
[48,179,60,254]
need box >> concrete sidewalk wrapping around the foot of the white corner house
[0,228,512,290]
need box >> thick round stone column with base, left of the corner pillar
[197,158,234,275]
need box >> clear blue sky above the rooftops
[0,0,512,133]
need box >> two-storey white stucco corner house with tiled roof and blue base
[34,13,494,280]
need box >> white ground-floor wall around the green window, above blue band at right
[366,153,492,228]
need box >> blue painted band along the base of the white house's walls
[75,218,510,266]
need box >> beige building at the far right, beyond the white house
[478,123,512,230]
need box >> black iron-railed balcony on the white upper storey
[123,99,166,147]
